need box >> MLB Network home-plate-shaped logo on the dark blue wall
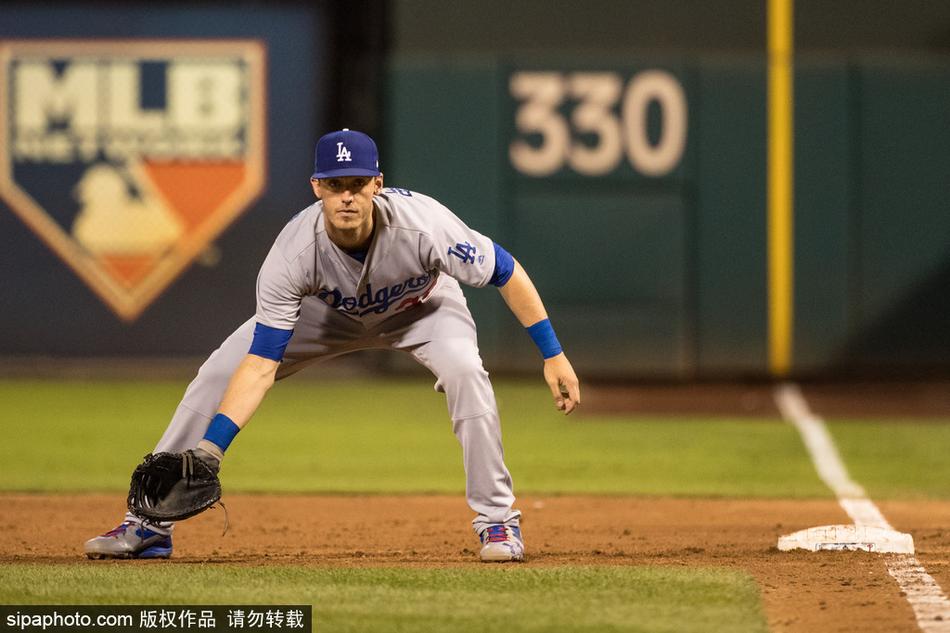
[0,40,265,321]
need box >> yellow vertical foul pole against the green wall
[768,0,795,376]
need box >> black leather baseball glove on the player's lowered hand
[128,448,221,521]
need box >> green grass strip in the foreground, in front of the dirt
[0,563,767,633]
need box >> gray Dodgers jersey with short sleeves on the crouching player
[255,188,495,330]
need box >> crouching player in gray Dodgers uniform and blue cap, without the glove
[85,129,580,561]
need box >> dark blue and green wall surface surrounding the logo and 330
[0,0,950,377]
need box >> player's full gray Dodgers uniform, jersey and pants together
[146,188,520,533]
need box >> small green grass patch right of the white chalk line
[828,419,950,499]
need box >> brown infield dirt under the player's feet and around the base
[0,494,950,632]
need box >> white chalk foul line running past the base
[775,384,950,633]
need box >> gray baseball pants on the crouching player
[129,277,521,534]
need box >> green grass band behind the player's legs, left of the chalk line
[0,377,830,497]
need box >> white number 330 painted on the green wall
[508,70,687,178]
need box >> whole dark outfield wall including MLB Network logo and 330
[0,0,950,378]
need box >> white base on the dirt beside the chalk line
[778,525,914,554]
